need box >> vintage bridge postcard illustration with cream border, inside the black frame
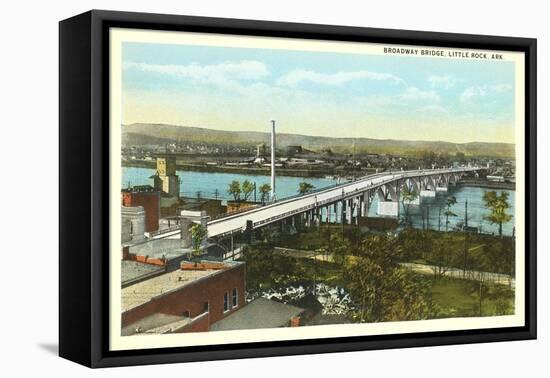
[110,29,525,348]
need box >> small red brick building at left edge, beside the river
[122,185,160,232]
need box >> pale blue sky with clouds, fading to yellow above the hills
[123,43,515,143]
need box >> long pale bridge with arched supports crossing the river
[154,167,483,239]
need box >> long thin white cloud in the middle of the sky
[277,69,404,87]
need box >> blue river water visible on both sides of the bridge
[122,167,515,235]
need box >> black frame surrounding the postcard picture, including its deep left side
[59,10,537,367]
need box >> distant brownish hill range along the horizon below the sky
[122,123,515,158]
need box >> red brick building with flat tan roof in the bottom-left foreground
[122,261,246,335]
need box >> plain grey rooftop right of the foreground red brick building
[210,298,304,331]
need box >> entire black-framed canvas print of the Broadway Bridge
[59,11,536,367]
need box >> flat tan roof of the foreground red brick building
[121,261,242,312]
